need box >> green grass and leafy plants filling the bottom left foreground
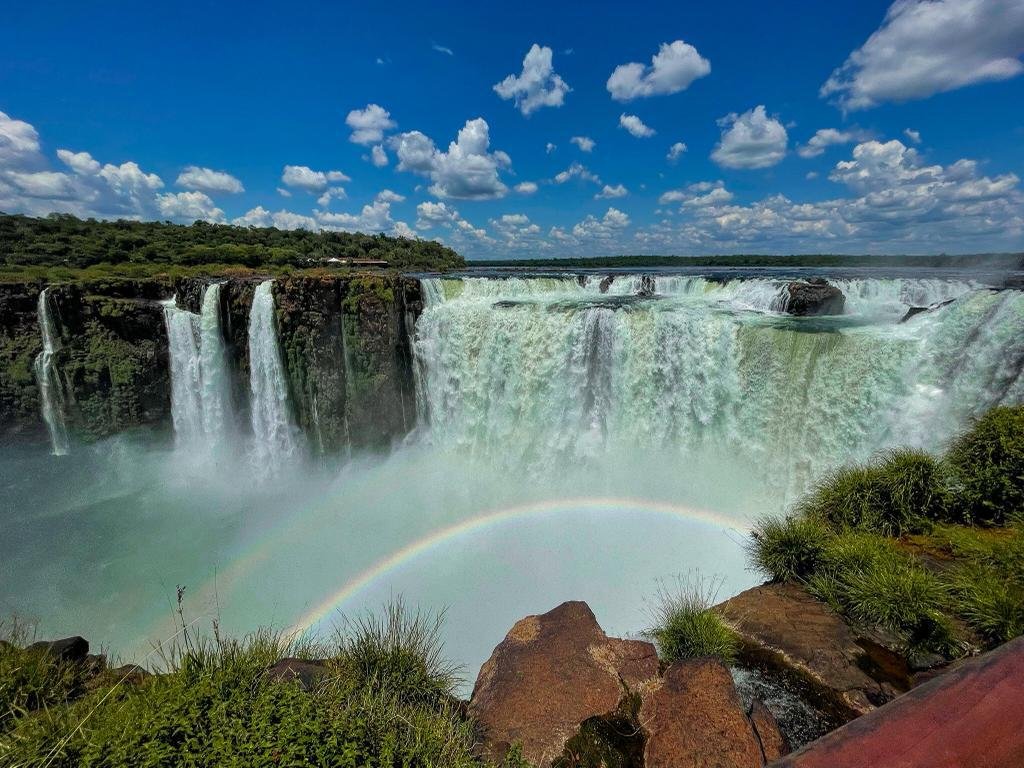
[0,603,512,768]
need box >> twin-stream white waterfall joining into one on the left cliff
[164,283,233,450]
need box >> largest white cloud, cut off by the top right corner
[821,0,1024,110]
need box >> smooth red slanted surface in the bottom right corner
[773,638,1024,768]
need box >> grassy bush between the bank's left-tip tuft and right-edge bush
[796,449,946,536]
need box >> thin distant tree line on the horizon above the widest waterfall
[467,253,1024,269]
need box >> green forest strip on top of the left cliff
[0,214,464,278]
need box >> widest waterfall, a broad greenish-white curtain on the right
[416,276,1024,499]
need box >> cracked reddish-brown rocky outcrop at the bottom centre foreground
[469,602,784,768]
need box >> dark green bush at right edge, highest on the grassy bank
[946,406,1024,525]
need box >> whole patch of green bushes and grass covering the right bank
[750,406,1024,656]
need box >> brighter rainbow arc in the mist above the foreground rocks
[290,497,750,634]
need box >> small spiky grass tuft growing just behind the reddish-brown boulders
[647,580,739,664]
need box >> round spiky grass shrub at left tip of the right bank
[746,517,830,582]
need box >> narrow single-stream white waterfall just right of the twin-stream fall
[249,280,299,475]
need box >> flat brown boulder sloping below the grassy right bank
[719,584,911,721]
